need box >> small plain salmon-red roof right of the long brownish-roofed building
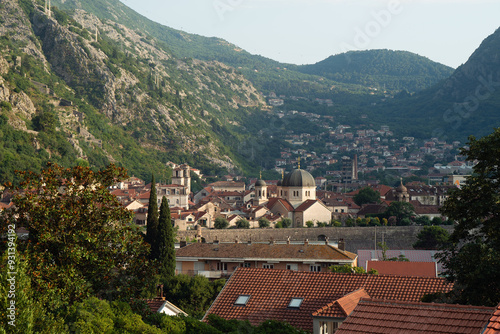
[366,261,437,277]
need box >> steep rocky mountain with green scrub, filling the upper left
[0,0,272,181]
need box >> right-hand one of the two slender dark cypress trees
[158,196,175,278]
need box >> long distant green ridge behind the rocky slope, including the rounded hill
[52,0,446,98]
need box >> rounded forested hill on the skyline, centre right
[298,50,453,92]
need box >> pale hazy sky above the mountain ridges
[120,0,500,67]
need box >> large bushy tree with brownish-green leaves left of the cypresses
[0,163,151,312]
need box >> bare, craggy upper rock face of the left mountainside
[0,1,265,177]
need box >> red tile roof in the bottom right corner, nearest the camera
[335,299,494,334]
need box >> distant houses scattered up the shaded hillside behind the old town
[271,103,474,182]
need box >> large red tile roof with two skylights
[205,268,453,332]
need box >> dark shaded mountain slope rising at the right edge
[372,28,500,141]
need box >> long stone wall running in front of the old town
[177,226,453,253]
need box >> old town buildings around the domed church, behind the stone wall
[104,160,463,230]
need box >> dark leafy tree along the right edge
[441,128,500,306]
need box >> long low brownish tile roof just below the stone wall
[176,243,357,263]
